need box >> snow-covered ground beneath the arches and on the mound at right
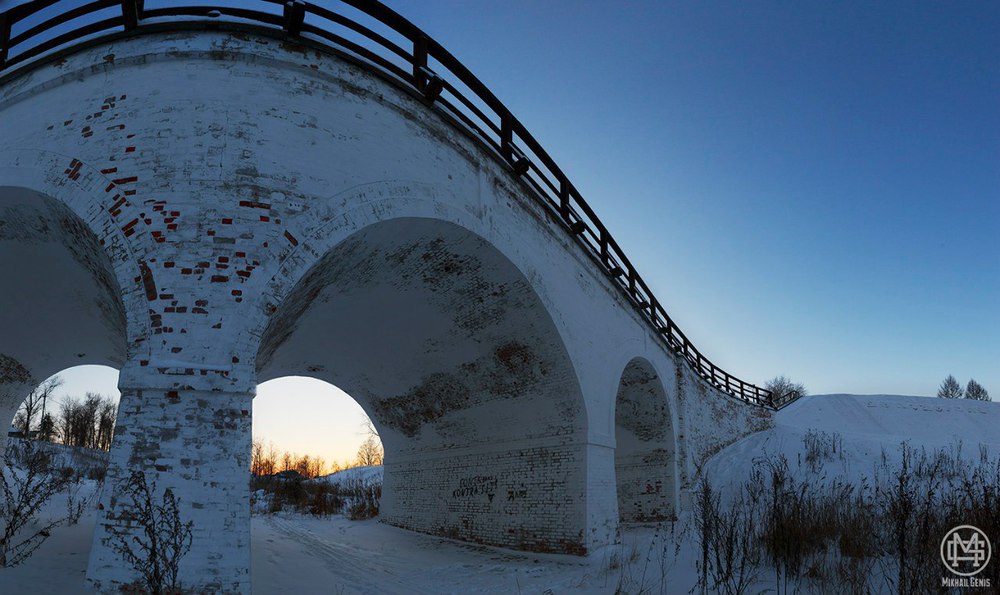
[0,395,1000,595]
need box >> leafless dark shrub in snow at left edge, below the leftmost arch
[0,441,70,568]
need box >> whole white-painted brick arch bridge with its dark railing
[0,0,778,592]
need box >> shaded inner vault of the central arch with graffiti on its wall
[257,218,587,553]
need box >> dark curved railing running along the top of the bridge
[0,0,793,408]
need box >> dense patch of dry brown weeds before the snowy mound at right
[692,442,1000,594]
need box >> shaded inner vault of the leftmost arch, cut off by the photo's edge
[0,186,127,450]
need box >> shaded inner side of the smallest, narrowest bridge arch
[615,358,677,523]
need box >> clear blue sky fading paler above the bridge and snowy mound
[9,0,1000,458]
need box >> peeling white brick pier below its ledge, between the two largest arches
[87,370,253,593]
